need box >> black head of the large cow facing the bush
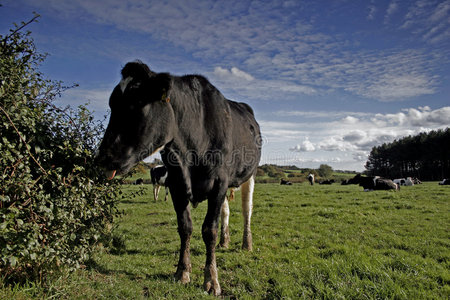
[96,62,175,178]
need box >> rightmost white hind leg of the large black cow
[241,176,255,251]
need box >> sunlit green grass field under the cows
[0,182,450,299]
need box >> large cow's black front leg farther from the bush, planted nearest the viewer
[202,189,226,296]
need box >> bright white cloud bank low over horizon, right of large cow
[261,106,450,170]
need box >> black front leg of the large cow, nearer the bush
[173,198,192,283]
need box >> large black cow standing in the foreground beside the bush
[97,62,261,295]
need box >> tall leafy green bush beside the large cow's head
[0,16,119,282]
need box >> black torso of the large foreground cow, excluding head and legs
[167,75,261,191]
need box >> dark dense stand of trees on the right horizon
[365,128,450,180]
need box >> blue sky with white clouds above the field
[0,0,450,171]
